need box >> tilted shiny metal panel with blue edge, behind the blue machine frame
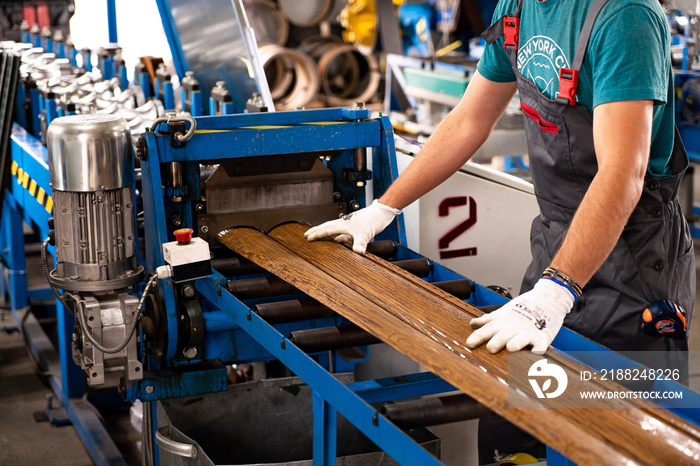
[159,0,274,113]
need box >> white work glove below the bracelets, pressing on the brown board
[467,277,576,353]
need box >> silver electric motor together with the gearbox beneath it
[47,114,144,387]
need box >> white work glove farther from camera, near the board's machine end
[304,199,401,254]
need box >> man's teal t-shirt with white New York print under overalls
[477,0,674,175]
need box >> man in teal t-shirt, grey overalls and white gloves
[307,0,696,459]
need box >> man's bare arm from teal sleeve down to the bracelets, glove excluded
[551,100,653,286]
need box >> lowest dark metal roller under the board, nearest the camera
[381,394,493,429]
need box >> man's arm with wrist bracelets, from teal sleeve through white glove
[467,100,653,353]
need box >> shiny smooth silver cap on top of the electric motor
[47,114,134,192]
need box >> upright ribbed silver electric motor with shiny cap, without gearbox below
[47,114,143,292]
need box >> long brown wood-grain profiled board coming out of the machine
[219,223,700,465]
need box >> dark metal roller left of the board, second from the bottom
[289,325,382,353]
